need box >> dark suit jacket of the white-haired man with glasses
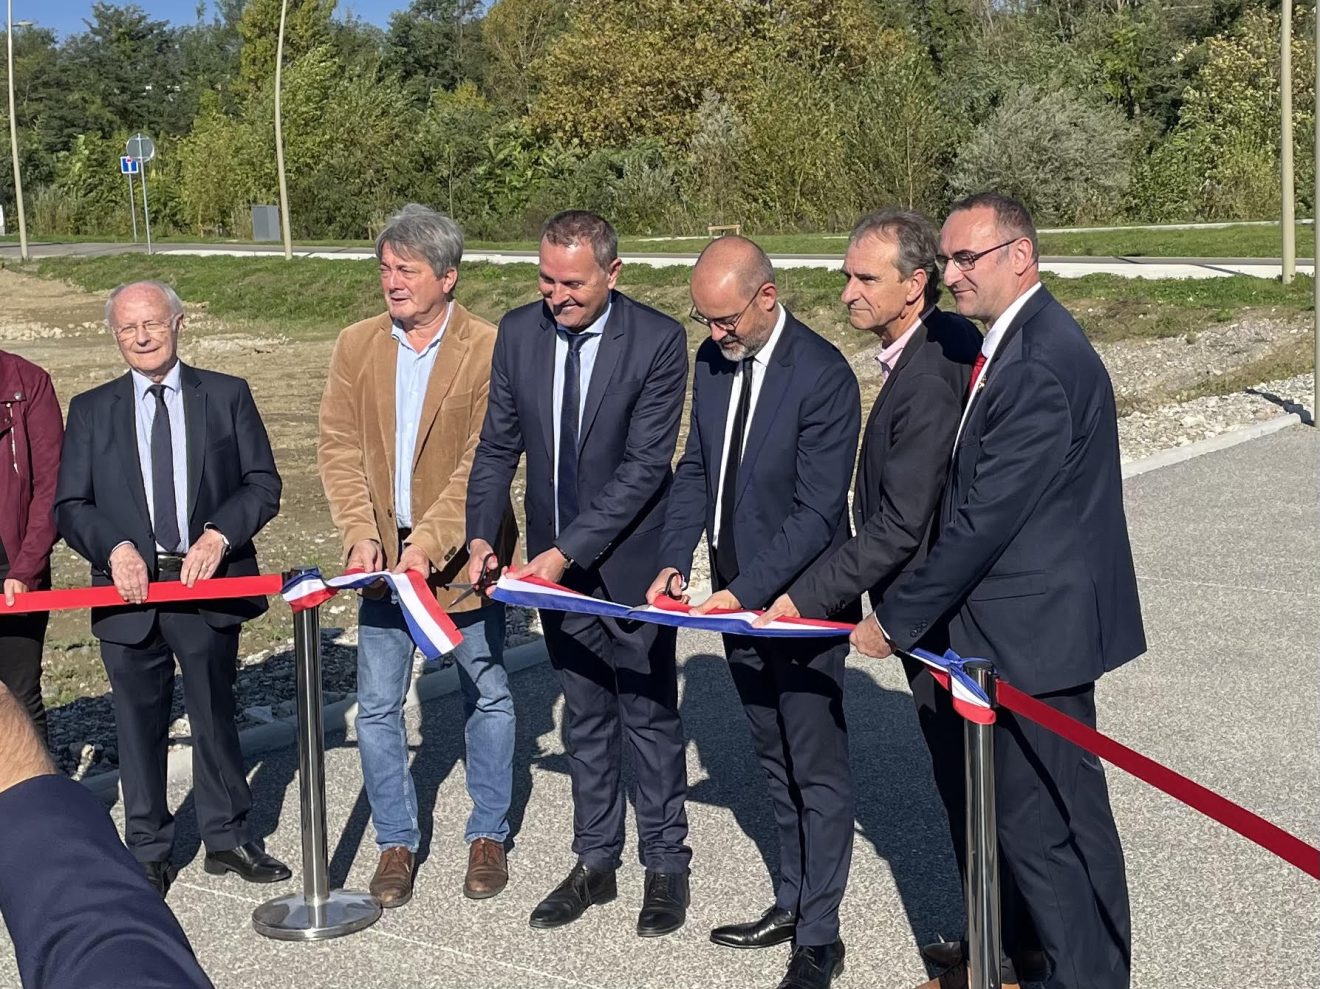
[55,364,281,646]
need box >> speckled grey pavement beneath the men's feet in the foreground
[0,426,1320,989]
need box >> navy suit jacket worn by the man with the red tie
[876,287,1146,693]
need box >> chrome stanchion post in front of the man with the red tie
[964,659,1001,989]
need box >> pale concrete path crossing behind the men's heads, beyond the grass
[0,243,1315,279]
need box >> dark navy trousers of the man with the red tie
[994,684,1131,989]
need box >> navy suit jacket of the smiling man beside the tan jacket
[467,292,688,605]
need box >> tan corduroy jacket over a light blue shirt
[317,302,517,611]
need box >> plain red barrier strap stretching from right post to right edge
[995,680,1320,879]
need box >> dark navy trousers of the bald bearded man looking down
[723,635,854,945]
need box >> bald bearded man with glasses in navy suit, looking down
[647,238,861,989]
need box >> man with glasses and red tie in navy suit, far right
[853,193,1146,989]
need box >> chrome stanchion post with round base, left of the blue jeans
[252,570,380,941]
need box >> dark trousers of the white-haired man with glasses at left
[100,609,252,862]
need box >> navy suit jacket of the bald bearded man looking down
[660,313,862,607]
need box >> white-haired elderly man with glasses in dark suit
[55,281,289,895]
